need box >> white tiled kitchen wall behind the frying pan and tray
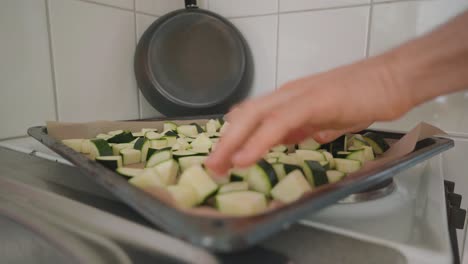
[0,0,468,139]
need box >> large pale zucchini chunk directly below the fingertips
[178,165,218,203]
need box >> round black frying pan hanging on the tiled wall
[135,0,253,116]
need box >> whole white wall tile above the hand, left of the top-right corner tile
[278,7,369,85]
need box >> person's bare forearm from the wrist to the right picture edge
[382,11,468,107]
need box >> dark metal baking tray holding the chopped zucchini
[28,116,454,252]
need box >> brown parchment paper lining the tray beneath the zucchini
[47,119,446,218]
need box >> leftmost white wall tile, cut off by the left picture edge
[0,0,55,138]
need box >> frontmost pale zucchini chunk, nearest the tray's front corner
[215,191,268,216]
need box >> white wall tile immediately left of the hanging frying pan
[50,0,138,121]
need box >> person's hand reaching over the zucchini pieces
[206,57,413,175]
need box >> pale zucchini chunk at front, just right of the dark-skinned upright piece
[271,170,311,203]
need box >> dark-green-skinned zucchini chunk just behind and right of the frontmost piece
[247,159,278,195]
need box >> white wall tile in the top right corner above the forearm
[369,0,468,55]
